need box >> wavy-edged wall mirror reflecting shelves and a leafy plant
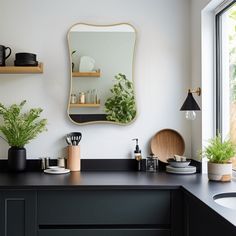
[68,23,137,124]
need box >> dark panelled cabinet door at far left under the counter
[0,190,36,236]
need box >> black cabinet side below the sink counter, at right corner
[185,193,236,236]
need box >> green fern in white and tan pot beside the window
[201,134,236,182]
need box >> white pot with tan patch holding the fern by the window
[208,162,232,182]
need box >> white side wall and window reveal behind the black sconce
[191,0,223,162]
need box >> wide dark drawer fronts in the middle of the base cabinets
[37,189,174,236]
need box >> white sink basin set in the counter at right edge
[213,192,236,210]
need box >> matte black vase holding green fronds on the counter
[8,147,26,172]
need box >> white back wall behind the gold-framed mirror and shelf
[0,0,191,158]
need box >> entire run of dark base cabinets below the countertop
[0,188,236,236]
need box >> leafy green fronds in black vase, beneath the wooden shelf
[0,100,47,171]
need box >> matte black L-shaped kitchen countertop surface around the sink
[0,171,236,227]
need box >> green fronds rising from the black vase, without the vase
[0,100,47,147]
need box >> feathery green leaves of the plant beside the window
[201,134,236,164]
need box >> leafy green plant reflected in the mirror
[105,74,136,123]
